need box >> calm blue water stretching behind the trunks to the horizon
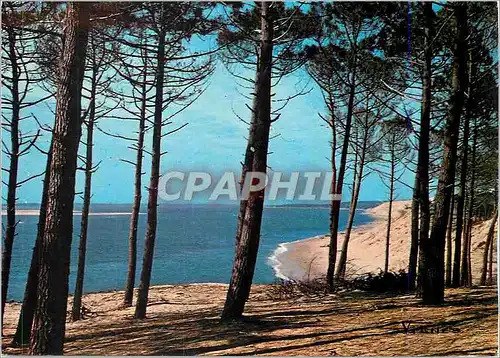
[8,205,370,300]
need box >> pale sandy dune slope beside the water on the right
[275,201,497,282]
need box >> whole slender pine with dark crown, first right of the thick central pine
[309,3,390,291]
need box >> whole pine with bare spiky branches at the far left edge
[1,2,53,328]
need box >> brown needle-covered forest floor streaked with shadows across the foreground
[3,284,498,356]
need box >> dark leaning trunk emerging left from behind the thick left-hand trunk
[12,139,53,346]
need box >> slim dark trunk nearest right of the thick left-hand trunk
[71,66,97,321]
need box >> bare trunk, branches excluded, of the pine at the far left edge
[1,29,21,332]
